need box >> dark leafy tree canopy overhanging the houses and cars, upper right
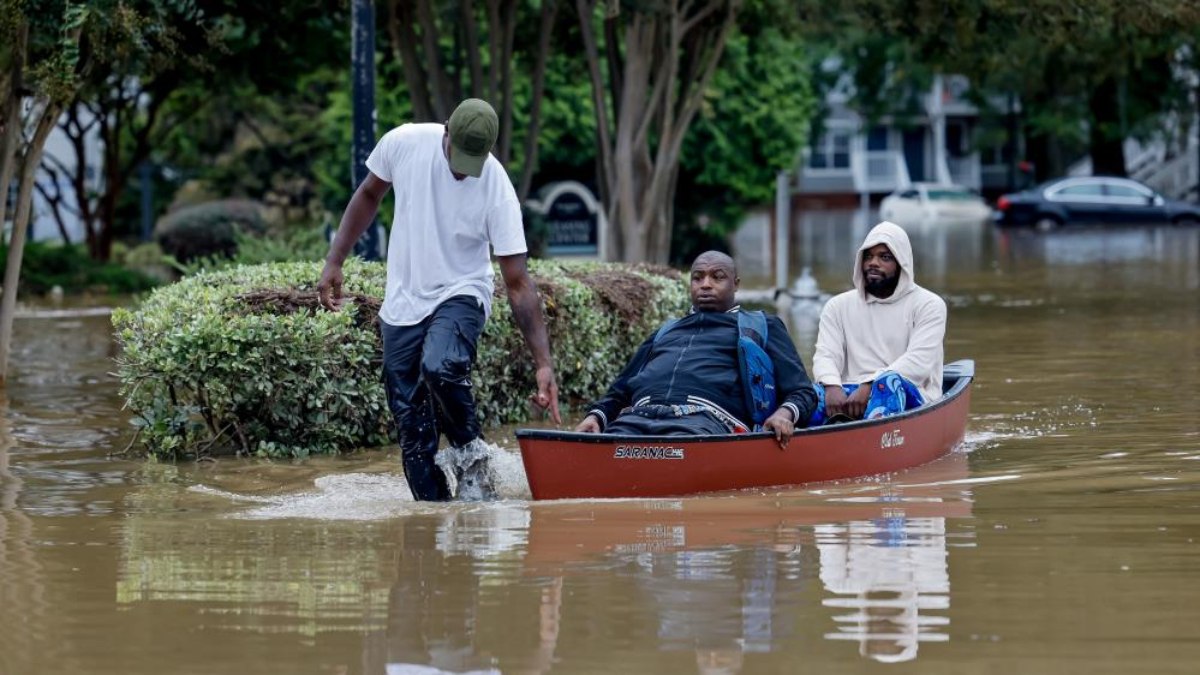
[803,0,1200,175]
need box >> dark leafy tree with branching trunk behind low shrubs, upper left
[44,0,348,259]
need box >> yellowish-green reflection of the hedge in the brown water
[116,465,386,635]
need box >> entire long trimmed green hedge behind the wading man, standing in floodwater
[113,261,688,458]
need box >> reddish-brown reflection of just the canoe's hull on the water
[524,453,971,575]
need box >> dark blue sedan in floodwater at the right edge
[996,175,1200,231]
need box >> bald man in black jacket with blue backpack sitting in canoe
[575,251,817,444]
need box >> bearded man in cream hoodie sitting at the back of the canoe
[809,221,946,426]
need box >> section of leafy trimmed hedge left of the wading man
[113,261,388,458]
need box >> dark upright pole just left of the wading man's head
[350,0,384,261]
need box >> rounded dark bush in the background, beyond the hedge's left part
[154,199,266,263]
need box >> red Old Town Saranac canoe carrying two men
[516,360,974,500]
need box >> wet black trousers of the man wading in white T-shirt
[379,295,484,501]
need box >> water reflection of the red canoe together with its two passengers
[511,454,971,673]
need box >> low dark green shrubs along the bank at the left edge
[0,241,158,295]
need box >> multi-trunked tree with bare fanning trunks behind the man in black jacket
[576,0,742,263]
